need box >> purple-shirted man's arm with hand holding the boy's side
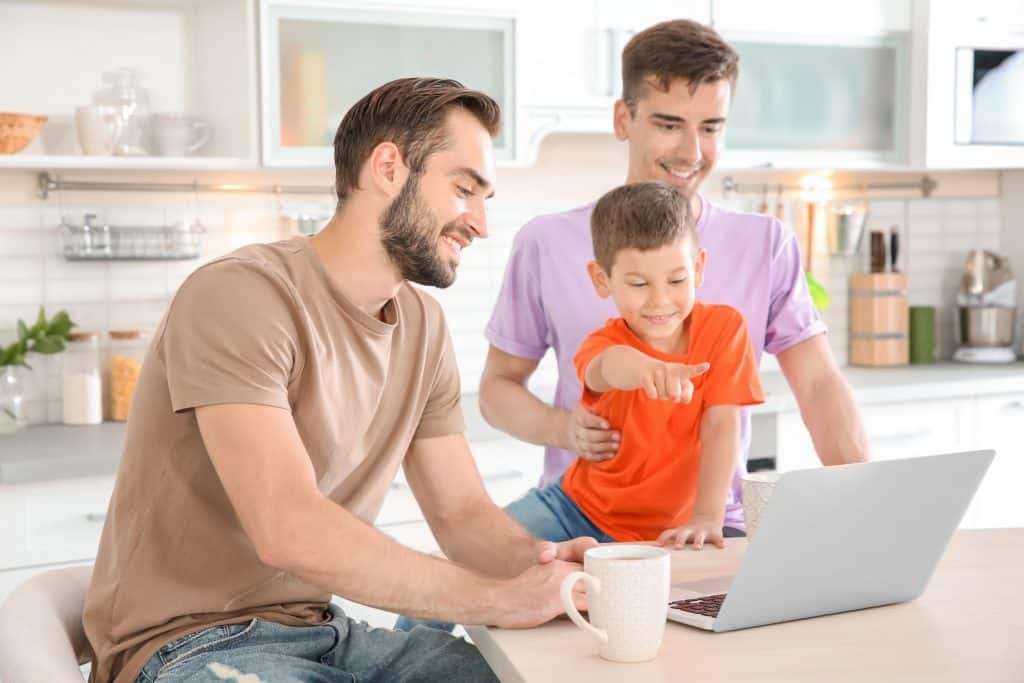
[480,345,620,461]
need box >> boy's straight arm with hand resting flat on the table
[657,405,739,550]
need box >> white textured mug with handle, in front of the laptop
[561,545,672,661]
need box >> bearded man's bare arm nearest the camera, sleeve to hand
[196,404,579,627]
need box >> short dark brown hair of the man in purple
[623,19,739,114]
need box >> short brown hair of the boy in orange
[590,182,696,274]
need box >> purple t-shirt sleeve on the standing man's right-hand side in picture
[765,224,827,353]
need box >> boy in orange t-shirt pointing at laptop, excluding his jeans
[561,182,764,548]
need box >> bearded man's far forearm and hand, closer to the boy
[403,434,597,578]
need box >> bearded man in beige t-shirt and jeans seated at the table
[83,79,594,683]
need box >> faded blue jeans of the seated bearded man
[136,605,498,683]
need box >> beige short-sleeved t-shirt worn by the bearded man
[83,238,464,683]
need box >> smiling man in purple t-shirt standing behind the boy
[480,20,866,536]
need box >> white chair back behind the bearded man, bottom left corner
[0,565,92,683]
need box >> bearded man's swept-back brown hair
[334,78,502,204]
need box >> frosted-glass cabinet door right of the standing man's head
[723,31,909,168]
